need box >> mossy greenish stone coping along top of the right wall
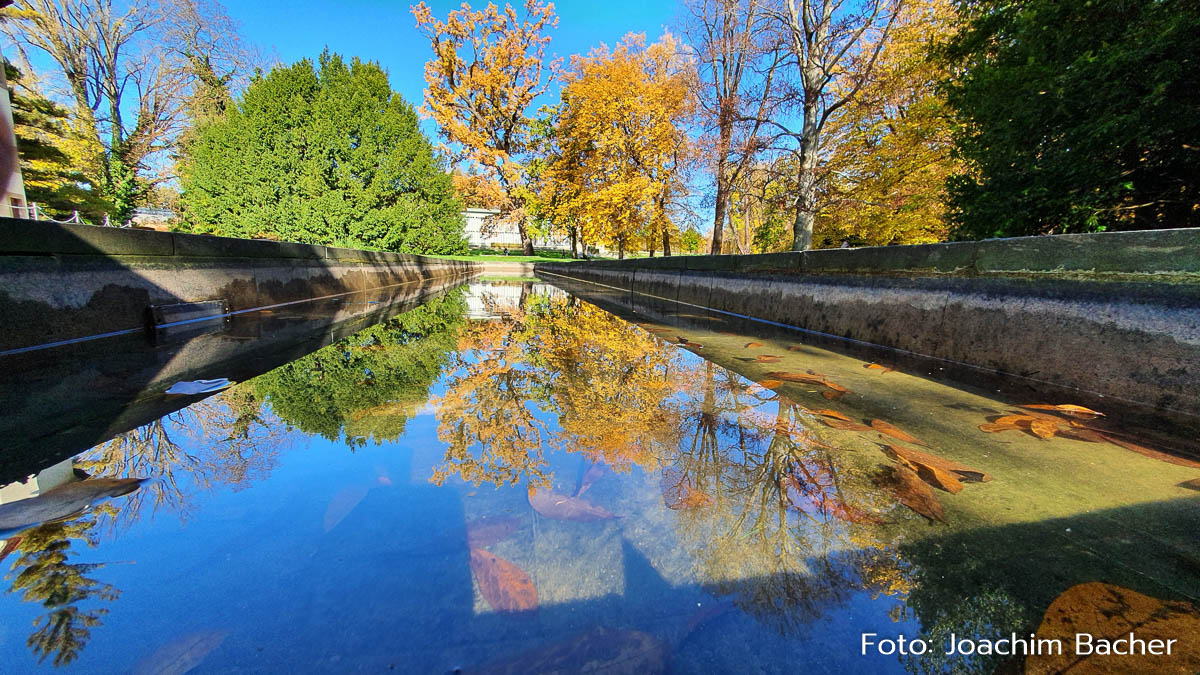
[538,228,1200,278]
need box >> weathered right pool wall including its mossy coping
[536,229,1200,414]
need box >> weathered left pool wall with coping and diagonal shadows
[0,219,481,352]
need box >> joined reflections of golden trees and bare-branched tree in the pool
[434,289,907,632]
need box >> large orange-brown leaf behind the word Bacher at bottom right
[1025,581,1200,674]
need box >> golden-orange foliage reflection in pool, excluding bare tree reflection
[433,295,679,485]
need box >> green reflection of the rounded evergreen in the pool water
[253,288,467,448]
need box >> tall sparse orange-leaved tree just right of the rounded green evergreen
[412,0,558,256]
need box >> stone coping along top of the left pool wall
[0,217,479,268]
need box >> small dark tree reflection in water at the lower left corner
[6,515,120,665]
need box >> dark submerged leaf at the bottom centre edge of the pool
[479,627,670,675]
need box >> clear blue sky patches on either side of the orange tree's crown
[224,0,678,114]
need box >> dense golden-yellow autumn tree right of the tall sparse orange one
[544,34,695,257]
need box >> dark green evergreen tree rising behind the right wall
[947,0,1200,238]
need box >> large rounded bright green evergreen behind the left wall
[180,52,467,253]
